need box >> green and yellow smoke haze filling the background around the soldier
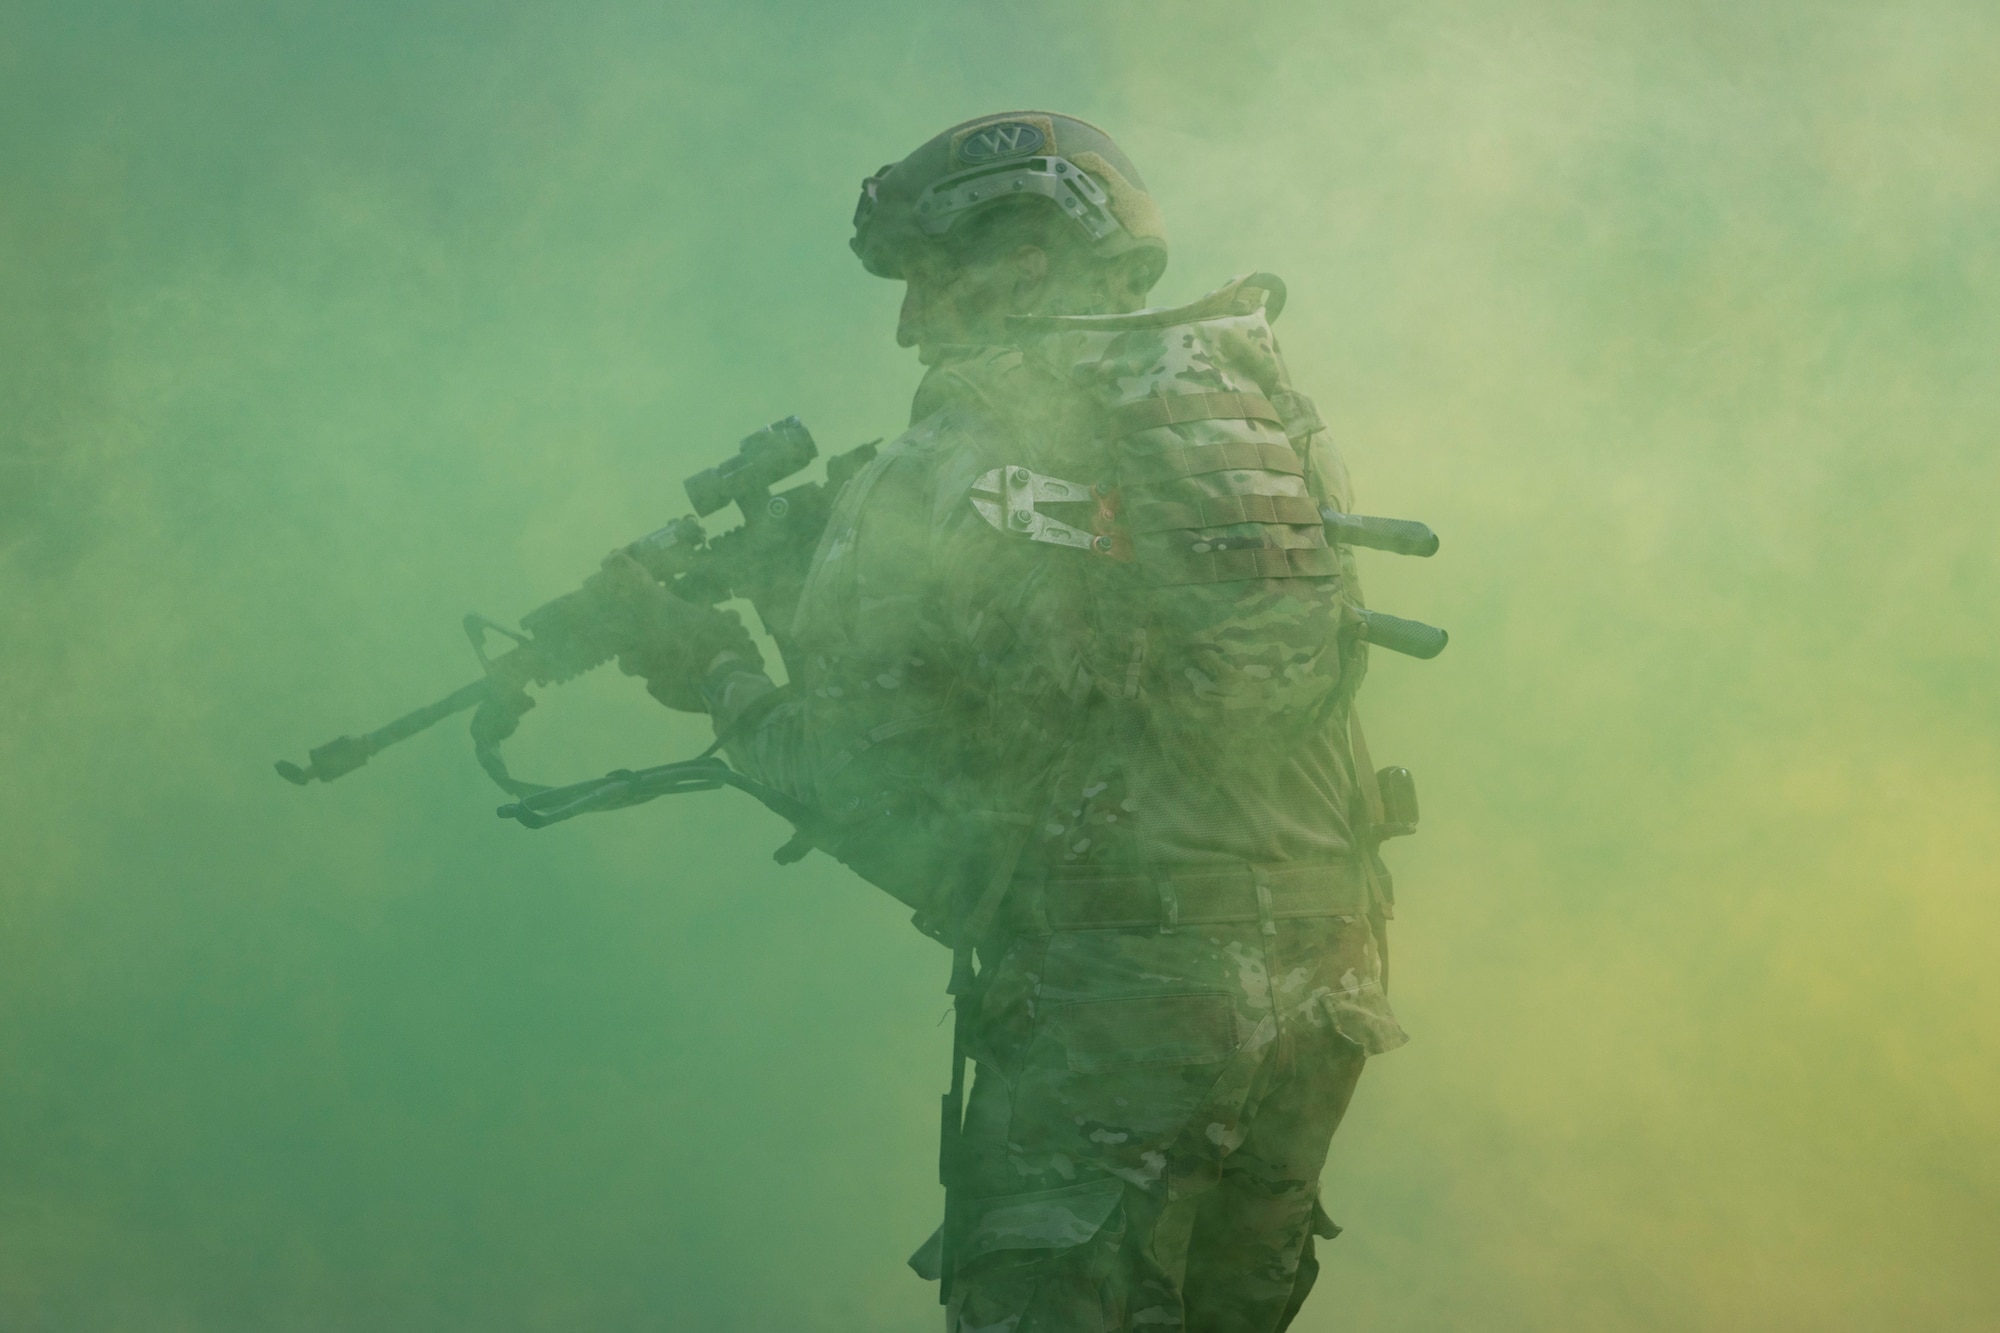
[0,0,2000,1333]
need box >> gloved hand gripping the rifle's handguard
[586,550,764,713]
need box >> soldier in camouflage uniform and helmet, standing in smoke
[620,112,1404,1333]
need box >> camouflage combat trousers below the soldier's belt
[948,917,1400,1333]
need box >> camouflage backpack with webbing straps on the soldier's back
[1018,280,1360,729]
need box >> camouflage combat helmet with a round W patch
[848,110,1166,278]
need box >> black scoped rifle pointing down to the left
[276,416,880,792]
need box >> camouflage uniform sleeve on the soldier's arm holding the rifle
[704,394,1016,935]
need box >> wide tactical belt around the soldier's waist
[1002,861,1372,935]
